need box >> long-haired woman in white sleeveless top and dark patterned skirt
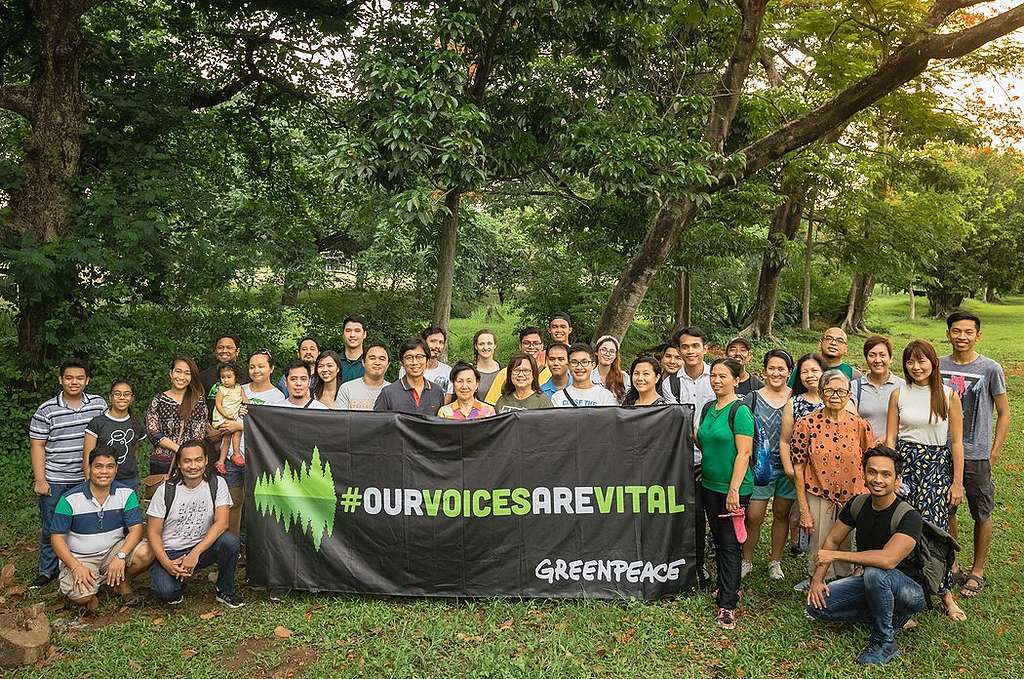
[886,340,967,621]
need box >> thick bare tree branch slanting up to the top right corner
[701,3,1024,193]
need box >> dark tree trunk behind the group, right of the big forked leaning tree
[739,183,806,339]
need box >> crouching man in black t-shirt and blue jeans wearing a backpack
[807,445,928,665]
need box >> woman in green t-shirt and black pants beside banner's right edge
[696,358,754,630]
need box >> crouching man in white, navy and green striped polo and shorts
[50,445,153,610]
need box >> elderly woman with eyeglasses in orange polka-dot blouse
[790,369,874,590]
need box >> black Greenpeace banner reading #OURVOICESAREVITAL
[245,406,696,599]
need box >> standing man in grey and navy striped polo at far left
[29,358,106,587]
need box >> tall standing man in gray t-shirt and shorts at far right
[939,311,1010,597]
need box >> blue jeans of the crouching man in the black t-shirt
[807,566,928,644]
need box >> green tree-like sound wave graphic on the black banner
[253,447,338,552]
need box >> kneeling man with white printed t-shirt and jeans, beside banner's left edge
[146,439,243,608]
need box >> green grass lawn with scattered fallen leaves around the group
[3,298,1024,679]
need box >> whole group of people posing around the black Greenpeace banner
[29,311,1010,664]
